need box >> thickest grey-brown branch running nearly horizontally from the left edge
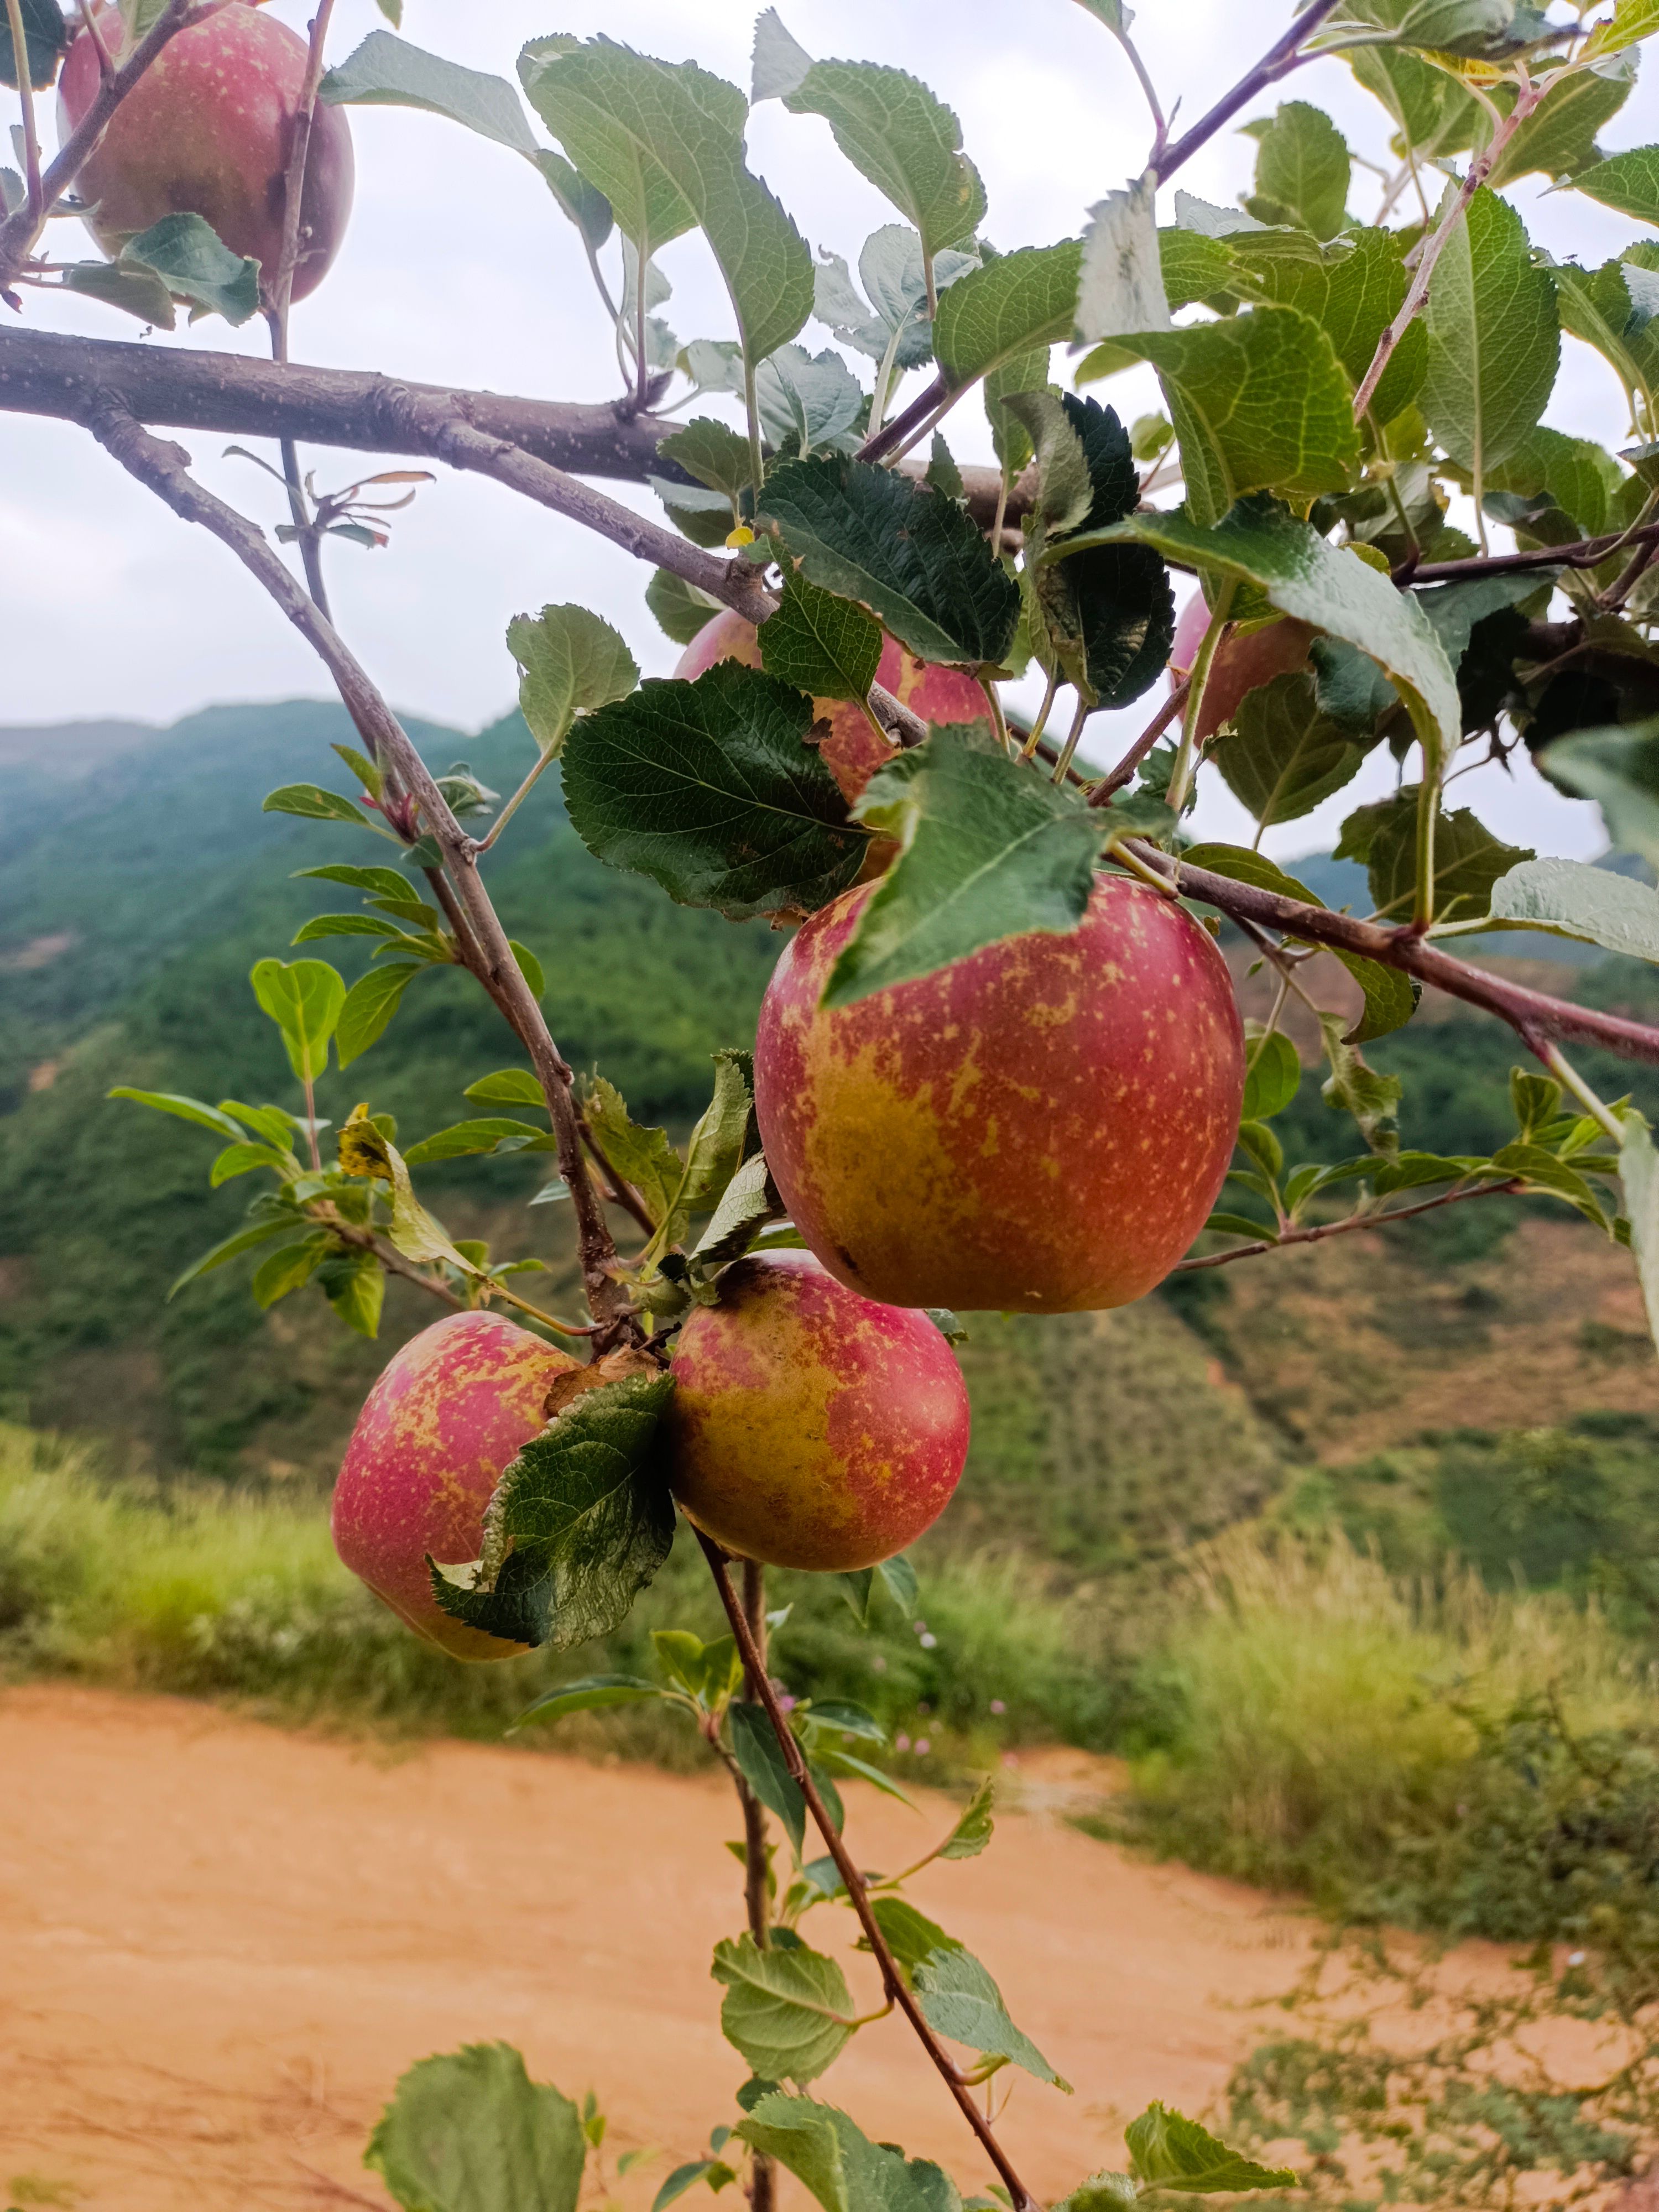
[0,325,1013,529]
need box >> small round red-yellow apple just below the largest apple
[668,1252,969,1575]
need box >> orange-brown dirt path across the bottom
[0,1688,1305,2212]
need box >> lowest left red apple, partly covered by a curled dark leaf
[334,1314,577,1659]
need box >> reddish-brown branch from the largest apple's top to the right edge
[1128,838,1659,1066]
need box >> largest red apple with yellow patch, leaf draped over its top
[754,876,1245,1314]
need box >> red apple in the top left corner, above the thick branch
[58,0,354,299]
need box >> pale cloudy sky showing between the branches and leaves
[0,0,1659,858]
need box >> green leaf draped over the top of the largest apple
[825,728,1106,1006]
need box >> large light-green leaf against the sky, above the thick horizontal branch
[522,38,812,363]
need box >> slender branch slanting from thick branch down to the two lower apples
[84,396,628,1349]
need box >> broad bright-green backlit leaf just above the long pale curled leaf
[1097,307,1360,524]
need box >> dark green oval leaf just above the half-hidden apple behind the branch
[765,453,1020,681]
